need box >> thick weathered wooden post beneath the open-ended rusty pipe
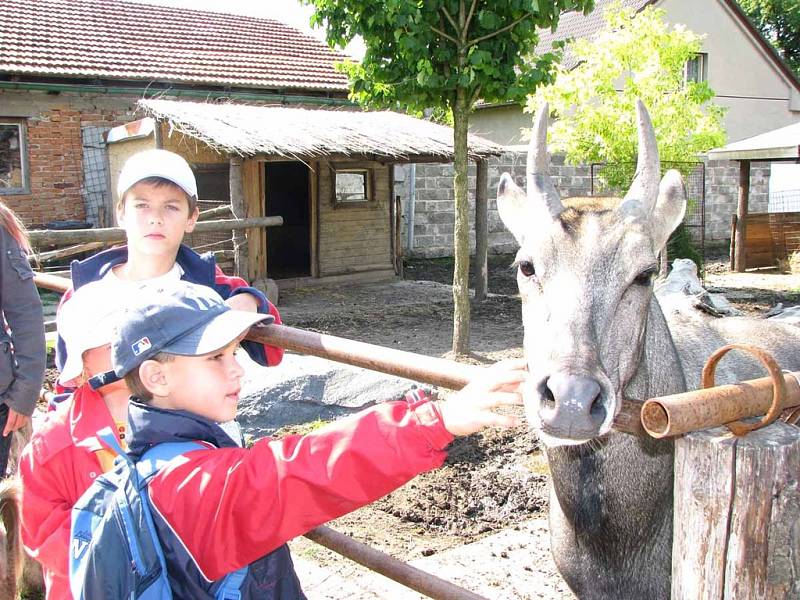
[672,421,800,600]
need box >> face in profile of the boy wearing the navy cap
[157,340,244,423]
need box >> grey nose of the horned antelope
[539,373,606,438]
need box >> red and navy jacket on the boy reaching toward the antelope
[128,397,453,598]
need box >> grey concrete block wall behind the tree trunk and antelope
[395,151,769,258]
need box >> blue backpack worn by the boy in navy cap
[69,427,247,600]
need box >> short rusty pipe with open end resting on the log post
[642,373,800,438]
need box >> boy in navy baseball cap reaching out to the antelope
[86,283,525,600]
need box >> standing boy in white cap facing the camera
[56,150,283,400]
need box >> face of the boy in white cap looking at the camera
[117,181,199,257]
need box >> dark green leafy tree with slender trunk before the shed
[303,0,593,354]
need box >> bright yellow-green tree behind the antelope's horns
[527,4,725,189]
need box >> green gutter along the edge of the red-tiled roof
[0,81,357,106]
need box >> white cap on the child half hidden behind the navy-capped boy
[56,279,123,387]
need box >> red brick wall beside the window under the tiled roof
[0,91,135,226]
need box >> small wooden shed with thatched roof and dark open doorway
[108,100,502,285]
